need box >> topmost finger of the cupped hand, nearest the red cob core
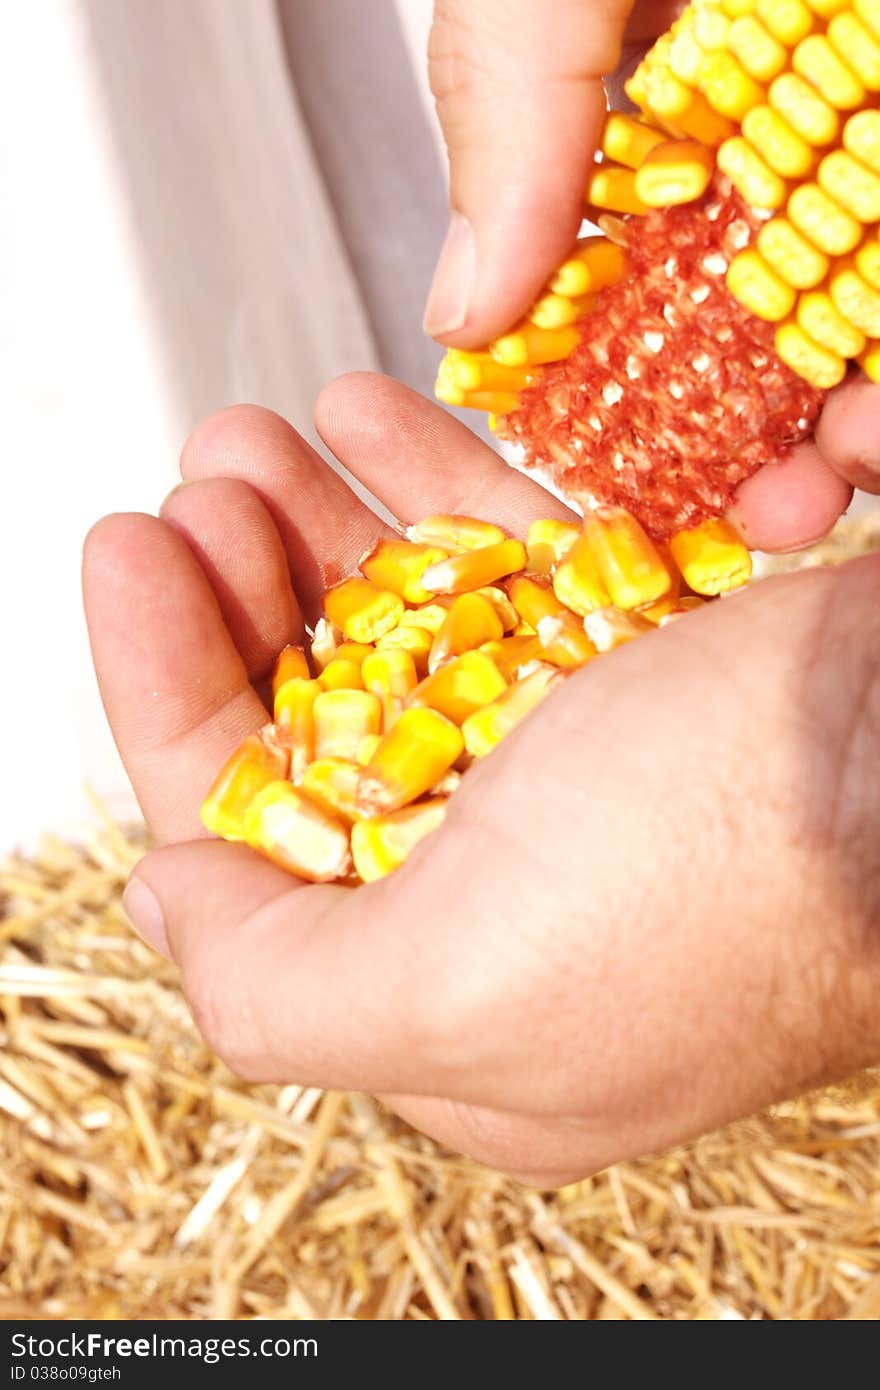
[316,371,577,532]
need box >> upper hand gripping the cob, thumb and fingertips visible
[425,0,880,549]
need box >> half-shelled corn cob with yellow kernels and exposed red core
[437,0,880,569]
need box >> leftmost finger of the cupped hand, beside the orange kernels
[83,513,268,841]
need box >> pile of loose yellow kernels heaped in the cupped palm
[202,510,749,883]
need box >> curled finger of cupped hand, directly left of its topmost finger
[181,406,388,619]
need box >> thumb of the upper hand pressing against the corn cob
[424,0,631,346]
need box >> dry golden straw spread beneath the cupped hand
[0,517,880,1319]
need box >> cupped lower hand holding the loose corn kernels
[85,374,880,1186]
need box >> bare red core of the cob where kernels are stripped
[498,175,824,539]
